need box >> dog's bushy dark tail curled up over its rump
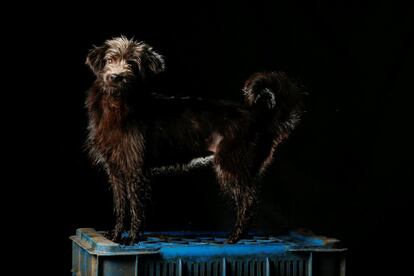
[243,72,303,143]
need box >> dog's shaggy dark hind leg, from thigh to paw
[214,141,257,243]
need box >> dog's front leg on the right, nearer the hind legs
[126,173,150,245]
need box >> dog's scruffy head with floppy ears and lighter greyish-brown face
[86,36,165,89]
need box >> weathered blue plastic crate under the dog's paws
[71,228,346,276]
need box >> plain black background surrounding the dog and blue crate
[5,1,414,275]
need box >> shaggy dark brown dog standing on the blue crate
[86,37,301,244]
